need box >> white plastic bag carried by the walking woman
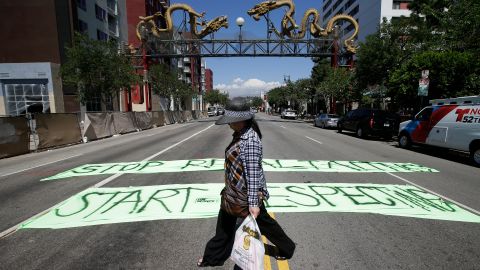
[230,215,265,270]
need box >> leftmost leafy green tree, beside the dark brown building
[61,33,140,104]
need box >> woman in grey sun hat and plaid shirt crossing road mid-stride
[197,100,295,269]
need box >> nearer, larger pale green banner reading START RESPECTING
[21,183,480,229]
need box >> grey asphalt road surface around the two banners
[0,113,480,269]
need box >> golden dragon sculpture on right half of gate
[247,0,358,53]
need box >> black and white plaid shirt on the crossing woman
[225,128,269,207]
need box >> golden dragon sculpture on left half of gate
[137,4,228,39]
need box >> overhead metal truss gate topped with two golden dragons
[124,0,359,111]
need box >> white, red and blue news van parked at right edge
[398,96,480,167]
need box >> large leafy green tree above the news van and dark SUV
[356,0,480,109]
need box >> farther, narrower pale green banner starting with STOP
[42,158,438,181]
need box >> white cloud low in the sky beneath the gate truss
[213,78,282,98]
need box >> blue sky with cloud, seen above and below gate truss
[171,0,322,97]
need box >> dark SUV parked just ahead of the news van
[337,109,400,139]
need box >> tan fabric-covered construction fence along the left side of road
[0,111,208,158]
